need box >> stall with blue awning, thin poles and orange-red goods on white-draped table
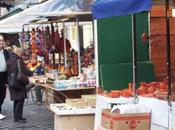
[93,0,174,130]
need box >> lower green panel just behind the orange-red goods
[100,62,155,91]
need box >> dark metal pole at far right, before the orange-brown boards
[165,0,171,106]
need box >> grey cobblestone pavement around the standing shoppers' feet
[0,90,54,130]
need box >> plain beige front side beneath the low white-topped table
[54,114,94,130]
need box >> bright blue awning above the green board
[92,0,152,19]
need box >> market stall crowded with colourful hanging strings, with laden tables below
[2,6,96,130]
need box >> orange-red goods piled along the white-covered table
[102,81,175,101]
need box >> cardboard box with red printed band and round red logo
[101,109,151,130]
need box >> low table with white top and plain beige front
[50,104,95,130]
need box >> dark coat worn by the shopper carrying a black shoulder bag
[7,53,33,101]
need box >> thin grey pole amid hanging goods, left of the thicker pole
[62,22,67,67]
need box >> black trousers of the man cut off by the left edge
[0,72,7,113]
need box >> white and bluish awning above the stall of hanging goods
[25,0,95,16]
